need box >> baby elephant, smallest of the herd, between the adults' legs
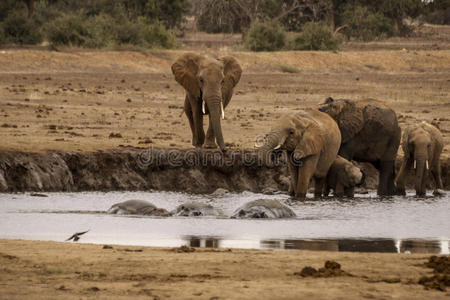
[324,155,365,197]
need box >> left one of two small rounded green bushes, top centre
[245,22,286,51]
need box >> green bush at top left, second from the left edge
[46,15,92,46]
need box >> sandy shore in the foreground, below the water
[0,240,450,299]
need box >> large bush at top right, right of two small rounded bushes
[341,5,395,42]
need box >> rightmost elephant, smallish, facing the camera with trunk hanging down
[395,121,444,196]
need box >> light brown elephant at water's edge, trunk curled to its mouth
[256,109,341,198]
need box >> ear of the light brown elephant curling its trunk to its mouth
[294,122,324,159]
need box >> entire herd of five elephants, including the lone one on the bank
[172,53,443,199]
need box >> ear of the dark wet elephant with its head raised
[336,100,364,144]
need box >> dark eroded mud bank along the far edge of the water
[0,149,450,193]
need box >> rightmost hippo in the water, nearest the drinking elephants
[231,199,295,219]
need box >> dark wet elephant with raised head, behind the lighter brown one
[319,97,401,196]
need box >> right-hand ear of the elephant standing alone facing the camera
[219,56,242,106]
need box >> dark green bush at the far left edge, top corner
[2,12,42,44]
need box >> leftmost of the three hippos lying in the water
[107,200,172,217]
